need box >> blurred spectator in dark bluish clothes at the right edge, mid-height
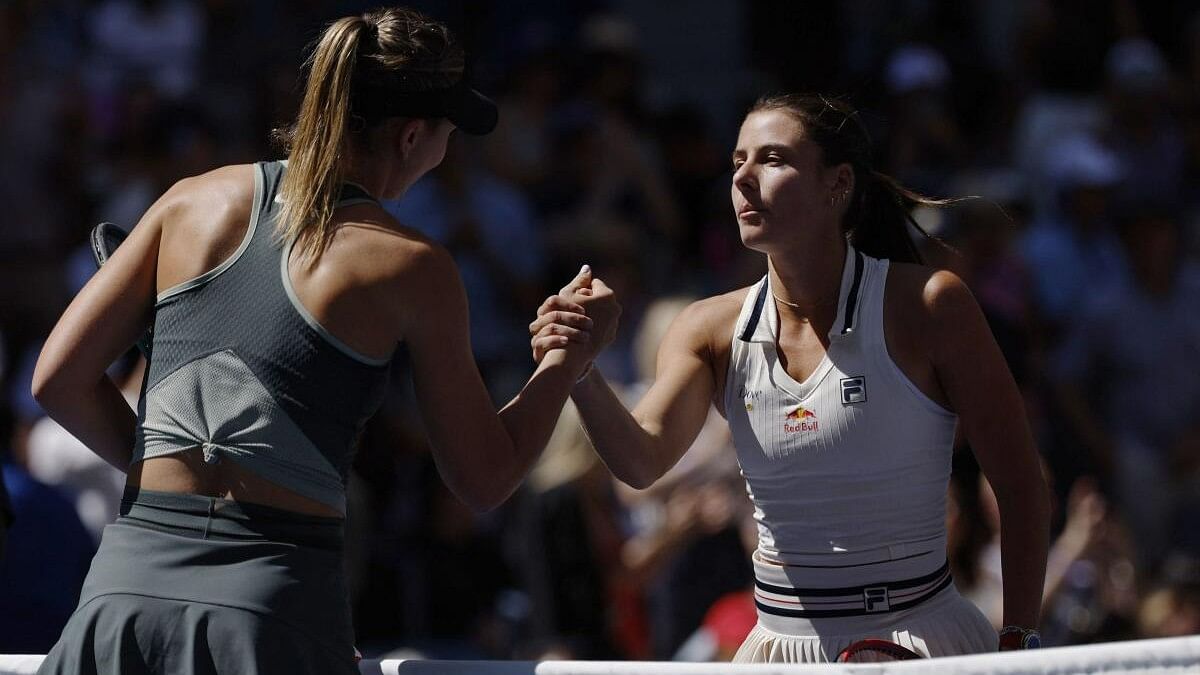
[1055,211,1200,569]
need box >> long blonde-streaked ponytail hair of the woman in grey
[276,7,464,262]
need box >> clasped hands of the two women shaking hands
[529,265,620,375]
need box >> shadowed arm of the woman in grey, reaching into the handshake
[404,254,620,510]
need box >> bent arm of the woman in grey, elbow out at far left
[32,186,169,471]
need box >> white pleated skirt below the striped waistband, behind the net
[733,584,998,663]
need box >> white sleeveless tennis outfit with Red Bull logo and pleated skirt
[725,246,997,662]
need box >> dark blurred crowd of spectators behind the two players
[0,0,1200,661]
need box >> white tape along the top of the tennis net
[0,635,1200,675]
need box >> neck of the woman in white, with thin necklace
[767,237,846,321]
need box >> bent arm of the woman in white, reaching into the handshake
[530,295,716,489]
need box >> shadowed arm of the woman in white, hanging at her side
[924,271,1050,628]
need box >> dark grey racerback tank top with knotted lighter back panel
[133,162,391,514]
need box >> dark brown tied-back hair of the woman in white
[746,94,958,263]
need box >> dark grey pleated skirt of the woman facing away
[38,490,359,675]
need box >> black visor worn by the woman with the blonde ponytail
[354,80,499,136]
